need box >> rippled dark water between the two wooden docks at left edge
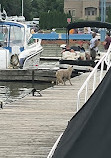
[0,82,52,104]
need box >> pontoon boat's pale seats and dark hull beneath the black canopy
[59,44,96,72]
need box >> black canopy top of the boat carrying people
[67,21,111,32]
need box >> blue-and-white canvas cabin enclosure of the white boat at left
[0,21,30,53]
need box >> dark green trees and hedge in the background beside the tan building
[0,0,111,29]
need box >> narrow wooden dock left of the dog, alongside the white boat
[0,67,57,82]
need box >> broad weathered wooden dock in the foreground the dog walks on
[0,73,104,158]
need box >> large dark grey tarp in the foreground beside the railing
[53,68,111,158]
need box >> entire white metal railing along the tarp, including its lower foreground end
[47,45,111,158]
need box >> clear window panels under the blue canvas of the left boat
[0,25,24,47]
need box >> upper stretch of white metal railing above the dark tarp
[77,44,111,111]
